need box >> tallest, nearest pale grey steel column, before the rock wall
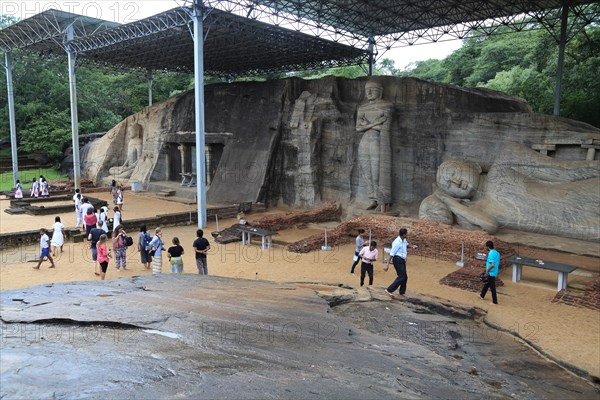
[192,0,206,228]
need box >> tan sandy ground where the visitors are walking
[0,192,600,376]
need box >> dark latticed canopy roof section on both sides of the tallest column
[73,8,368,76]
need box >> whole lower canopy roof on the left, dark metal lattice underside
[0,8,368,77]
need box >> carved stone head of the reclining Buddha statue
[436,159,481,199]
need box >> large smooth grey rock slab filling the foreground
[0,275,598,399]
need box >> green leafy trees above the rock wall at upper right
[401,21,600,127]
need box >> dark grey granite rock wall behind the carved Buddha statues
[84,77,600,215]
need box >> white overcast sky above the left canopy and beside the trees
[0,0,461,69]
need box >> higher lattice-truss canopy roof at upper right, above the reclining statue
[204,0,600,50]
